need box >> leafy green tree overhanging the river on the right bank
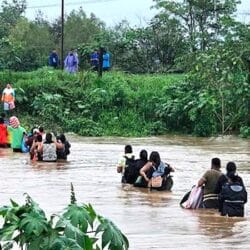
[158,19,250,136]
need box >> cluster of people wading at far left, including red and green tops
[0,113,71,162]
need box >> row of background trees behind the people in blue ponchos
[0,0,242,73]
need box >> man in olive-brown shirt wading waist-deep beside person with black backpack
[198,158,222,209]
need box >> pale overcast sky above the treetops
[23,0,250,26]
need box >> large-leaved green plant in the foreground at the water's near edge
[0,185,129,250]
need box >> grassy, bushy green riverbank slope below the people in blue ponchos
[0,68,249,136]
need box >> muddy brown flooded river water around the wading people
[0,136,250,250]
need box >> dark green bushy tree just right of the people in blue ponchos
[79,16,185,73]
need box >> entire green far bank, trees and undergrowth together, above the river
[0,0,250,136]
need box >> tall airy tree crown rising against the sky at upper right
[154,0,239,52]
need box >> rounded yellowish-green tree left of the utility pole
[1,18,54,71]
